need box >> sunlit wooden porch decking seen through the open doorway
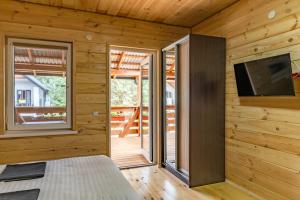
[111,136,150,168]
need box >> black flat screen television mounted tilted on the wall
[234,54,295,96]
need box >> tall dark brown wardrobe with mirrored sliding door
[162,34,225,187]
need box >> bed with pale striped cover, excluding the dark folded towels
[0,156,141,200]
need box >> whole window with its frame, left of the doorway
[6,38,72,131]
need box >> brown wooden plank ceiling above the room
[20,0,237,27]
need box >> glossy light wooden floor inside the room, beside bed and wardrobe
[122,166,257,200]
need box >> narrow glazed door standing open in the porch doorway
[140,55,153,162]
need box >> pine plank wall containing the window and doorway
[0,0,190,163]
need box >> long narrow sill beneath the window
[0,130,78,139]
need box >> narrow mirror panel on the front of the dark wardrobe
[164,48,176,167]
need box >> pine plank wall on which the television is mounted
[192,0,300,200]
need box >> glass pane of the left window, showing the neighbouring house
[14,45,67,125]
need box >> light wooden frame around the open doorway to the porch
[107,45,160,164]
